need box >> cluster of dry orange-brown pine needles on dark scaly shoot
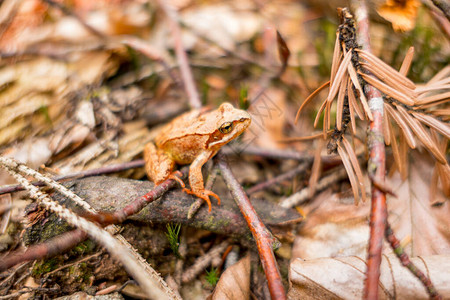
[296,10,450,203]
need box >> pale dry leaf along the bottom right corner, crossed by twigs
[288,254,450,299]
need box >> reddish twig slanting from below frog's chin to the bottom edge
[219,158,286,299]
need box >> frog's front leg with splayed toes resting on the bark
[184,151,220,211]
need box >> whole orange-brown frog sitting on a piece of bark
[144,103,251,211]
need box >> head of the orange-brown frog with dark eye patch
[208,103,251,148]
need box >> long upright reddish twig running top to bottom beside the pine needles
[351,0,387,299]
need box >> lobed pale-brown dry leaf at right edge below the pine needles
[387,151,450,256]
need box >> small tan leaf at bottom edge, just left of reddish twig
[212,255,250,300]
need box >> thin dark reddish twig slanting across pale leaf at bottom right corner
[384,222,442,300]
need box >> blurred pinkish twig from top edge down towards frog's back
[158,0,202,109]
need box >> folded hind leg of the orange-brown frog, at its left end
[144,143,184,188]
